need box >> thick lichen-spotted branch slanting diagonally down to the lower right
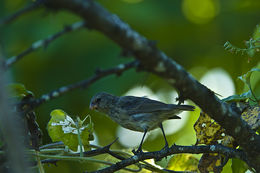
[46,0,260,172]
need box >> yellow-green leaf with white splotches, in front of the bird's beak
[47,109,93,151]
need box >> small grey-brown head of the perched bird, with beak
[89,92,116,114]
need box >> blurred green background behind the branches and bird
[0,0,260,172]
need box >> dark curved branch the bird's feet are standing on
[88,145,247,173]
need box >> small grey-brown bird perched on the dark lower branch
[89,92,195,154]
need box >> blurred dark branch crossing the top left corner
[0,0,44,26]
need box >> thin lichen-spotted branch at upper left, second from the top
[3,21,85,70]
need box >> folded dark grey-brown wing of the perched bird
[118,96,173,115]
